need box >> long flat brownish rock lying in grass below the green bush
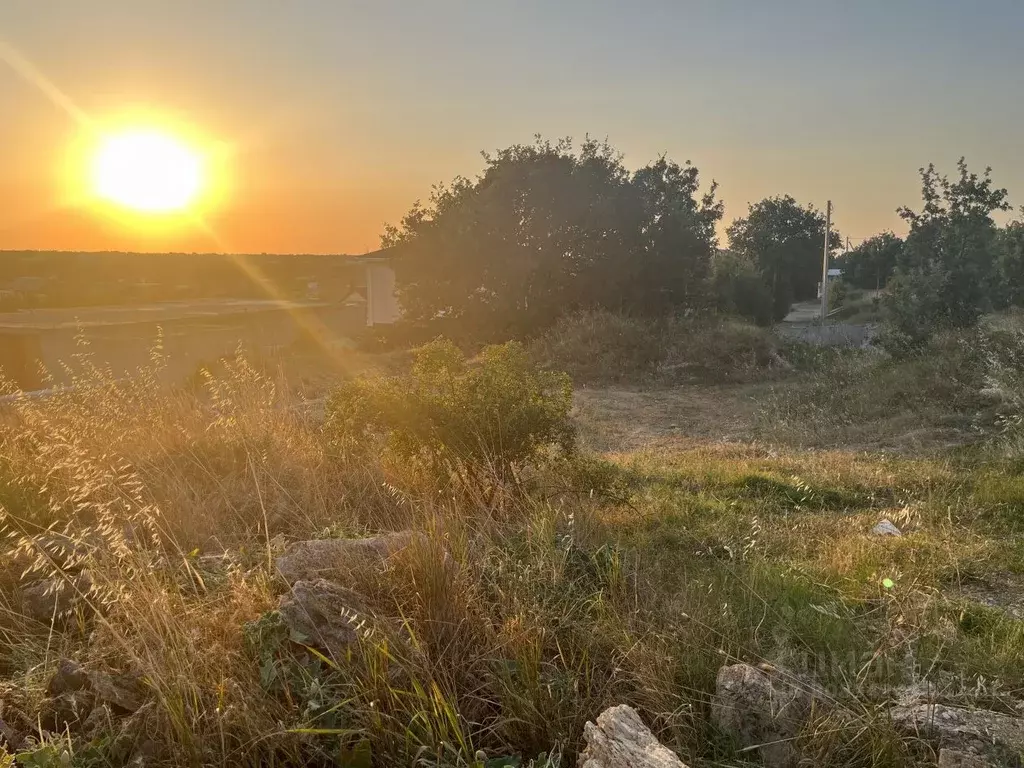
[275,530,428,584]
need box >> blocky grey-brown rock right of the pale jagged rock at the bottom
[712,664,825,768]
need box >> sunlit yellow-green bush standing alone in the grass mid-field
[326,339,574,479]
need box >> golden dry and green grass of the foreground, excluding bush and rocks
[0,339,1024,768]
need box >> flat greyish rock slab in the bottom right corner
[890,702,1024,768]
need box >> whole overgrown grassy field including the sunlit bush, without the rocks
[0,330,1024,768]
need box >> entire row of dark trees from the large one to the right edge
[382,136,1024,346]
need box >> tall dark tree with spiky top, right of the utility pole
[886,158,1010,350]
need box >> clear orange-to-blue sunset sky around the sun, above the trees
[0,0,1024,253]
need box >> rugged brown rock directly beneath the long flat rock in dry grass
[278,579,367,657]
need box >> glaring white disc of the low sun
[92,130,204,213]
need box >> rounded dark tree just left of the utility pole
[728,196,841,319]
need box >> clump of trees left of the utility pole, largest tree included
[382,137,840,340]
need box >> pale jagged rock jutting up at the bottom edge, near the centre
[579,705,686,768]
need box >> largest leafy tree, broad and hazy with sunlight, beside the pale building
[383,137,722,338]
